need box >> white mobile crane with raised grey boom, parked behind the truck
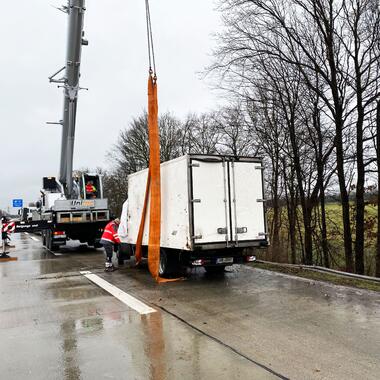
[33,0,110,250]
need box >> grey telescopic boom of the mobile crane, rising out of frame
[59,0,88,199]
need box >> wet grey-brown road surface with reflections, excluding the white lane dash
[0,234,380,380]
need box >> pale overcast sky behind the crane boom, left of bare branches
[0,0,220,211]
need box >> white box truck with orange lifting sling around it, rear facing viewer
[119,154,268,275]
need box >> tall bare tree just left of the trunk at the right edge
[340,0,380,274]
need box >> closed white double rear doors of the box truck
[190,156,266,248]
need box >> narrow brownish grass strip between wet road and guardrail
[250,263,380,292]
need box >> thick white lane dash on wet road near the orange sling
[79,271,157,314]
